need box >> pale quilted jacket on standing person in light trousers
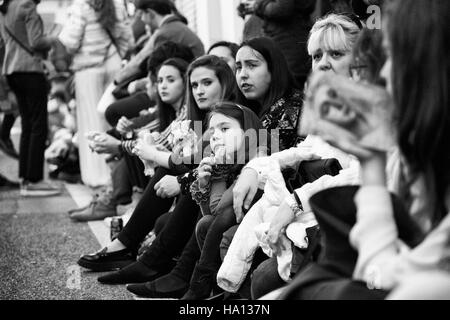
[59,0,134,71]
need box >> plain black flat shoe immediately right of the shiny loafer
[97,261,167,284]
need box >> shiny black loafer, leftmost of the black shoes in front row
[78,248,136,272]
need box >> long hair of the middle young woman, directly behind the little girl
[186,55,242,121]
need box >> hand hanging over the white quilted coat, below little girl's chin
[233,168,258,223]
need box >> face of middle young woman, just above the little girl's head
[190,67,222,110]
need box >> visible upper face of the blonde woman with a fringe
[311,37,353,77]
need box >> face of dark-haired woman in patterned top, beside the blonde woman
[236,47,272,102]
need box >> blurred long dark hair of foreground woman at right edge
[386,0,450,226]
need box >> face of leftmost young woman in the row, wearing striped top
[158,66,184,104]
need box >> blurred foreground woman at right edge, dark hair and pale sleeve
[349,0,450,299]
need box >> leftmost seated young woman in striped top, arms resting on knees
[69,58,188,221]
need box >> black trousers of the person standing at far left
[7,72,48,182]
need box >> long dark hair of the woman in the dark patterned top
[240,37,296,116]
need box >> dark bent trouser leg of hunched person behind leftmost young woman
[105,92,152,127]
